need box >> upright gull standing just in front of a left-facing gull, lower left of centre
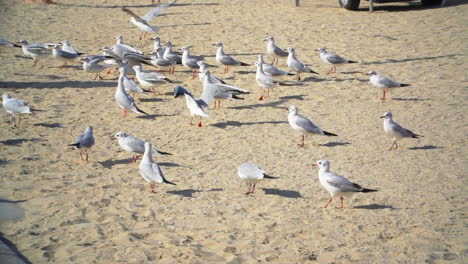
[140,142,176,192]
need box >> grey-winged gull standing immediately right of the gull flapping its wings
[200,70,250,109]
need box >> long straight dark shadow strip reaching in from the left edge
[0,81,117,89]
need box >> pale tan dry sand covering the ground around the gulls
[0,0,468,263]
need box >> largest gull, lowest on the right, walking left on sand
[313,160,377,208]
